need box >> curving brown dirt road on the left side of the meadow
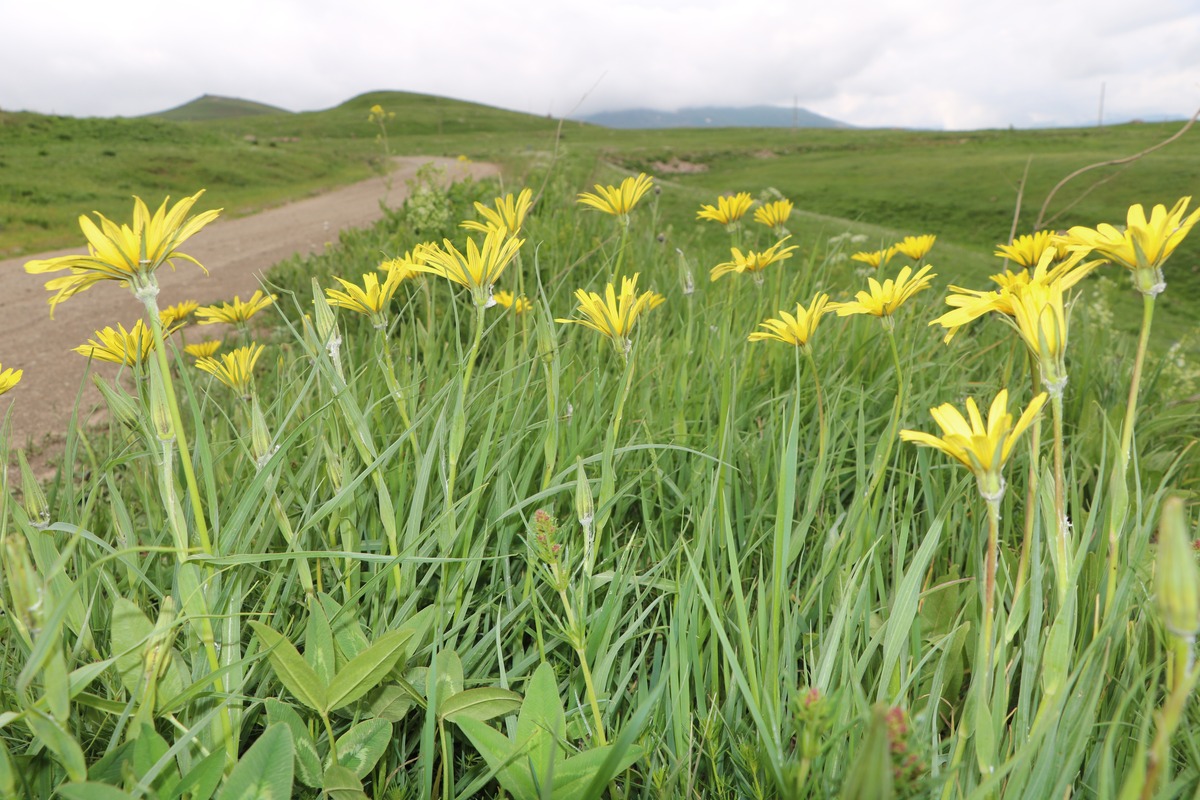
[0,156,498,461]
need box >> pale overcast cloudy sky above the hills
[0,0,1200,130]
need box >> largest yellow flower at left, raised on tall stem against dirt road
[25,190,221,318]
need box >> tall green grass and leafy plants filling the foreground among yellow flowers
[0,153,1200,798]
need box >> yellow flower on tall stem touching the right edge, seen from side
[1067,197,1200,296]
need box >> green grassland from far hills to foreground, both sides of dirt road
[0,92,1200,800]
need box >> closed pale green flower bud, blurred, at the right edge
[1154,497,1200,642]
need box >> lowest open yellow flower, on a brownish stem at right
[900,389,1046,503]
